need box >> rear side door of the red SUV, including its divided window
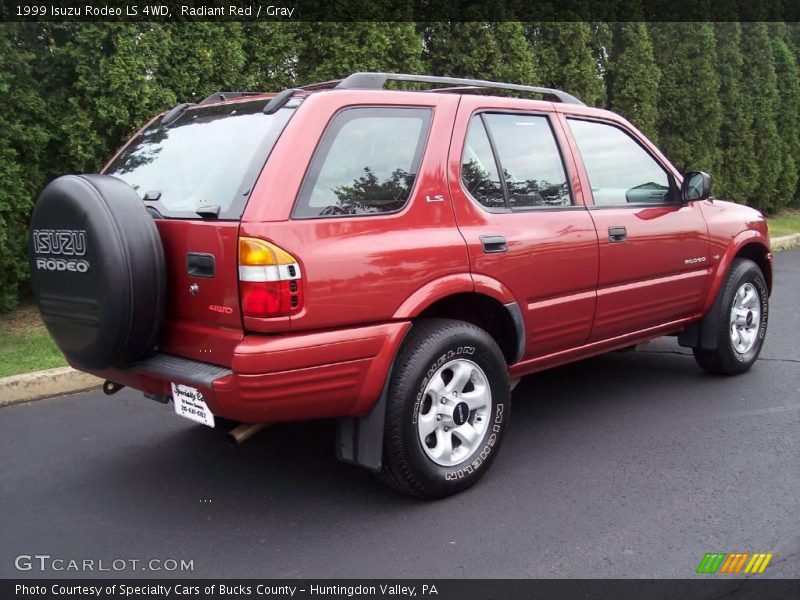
[449,96,597,360]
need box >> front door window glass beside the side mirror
[568,119,674,206]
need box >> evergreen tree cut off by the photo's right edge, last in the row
[769,23,800,211]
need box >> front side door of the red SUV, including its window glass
[566,117,711,341]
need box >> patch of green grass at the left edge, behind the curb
[0,306,67,377]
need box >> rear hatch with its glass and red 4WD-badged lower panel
[104,98,299,366]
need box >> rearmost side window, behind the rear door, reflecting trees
[293,107,431,219]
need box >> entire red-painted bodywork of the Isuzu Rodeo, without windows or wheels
[90,90,769,422]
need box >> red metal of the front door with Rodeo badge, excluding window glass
[561,112,711,342]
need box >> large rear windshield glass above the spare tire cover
[105,100,299,219]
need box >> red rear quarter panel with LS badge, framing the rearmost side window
[241,91,469,331]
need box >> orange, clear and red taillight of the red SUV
[239,237,303,318]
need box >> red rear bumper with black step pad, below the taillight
[86,321,410,422]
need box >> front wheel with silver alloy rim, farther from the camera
[693,258,769,375]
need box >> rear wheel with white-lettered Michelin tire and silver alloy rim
[380,319,511,499]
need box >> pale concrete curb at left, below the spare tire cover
[0,367,103,406]
